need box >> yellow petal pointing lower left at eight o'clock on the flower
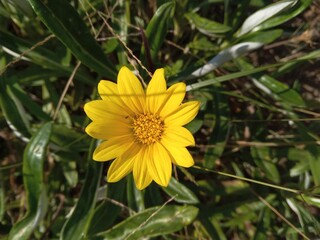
[93,136,134,162]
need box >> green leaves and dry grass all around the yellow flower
[0,0,320,240]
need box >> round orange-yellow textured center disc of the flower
[132,113,164,145]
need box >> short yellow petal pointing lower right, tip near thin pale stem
[165,145,194,167]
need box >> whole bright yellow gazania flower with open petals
[84,67,200,189]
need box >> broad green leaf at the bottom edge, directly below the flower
[92,205,198,240]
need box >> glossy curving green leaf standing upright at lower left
[9,122,52,240]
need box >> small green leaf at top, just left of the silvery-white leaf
[185,12,231,36]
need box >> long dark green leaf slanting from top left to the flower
[28,0,116,79]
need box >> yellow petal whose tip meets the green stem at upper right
[160,83,186,116]
